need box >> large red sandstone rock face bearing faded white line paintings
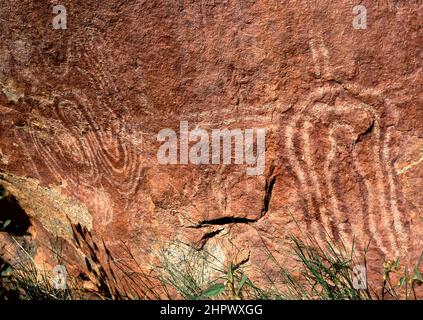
[0,0,423,296]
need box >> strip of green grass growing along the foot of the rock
[0,230,423,300]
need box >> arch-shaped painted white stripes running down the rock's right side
[284,85,408,257]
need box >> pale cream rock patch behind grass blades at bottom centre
[160,242,262,300]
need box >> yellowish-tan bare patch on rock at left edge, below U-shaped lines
[0,172,92,240]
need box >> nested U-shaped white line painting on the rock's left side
[16,32,146,229]
